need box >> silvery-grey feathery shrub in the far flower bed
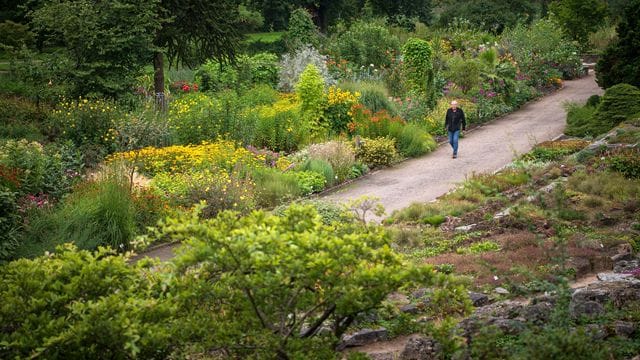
[278,45,336,92]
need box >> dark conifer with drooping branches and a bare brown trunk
[153,0,241,94]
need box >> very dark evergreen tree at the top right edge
[596,0,640,89]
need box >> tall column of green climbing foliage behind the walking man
[402,38,435,102]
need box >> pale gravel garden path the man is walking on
[134,72,602,261]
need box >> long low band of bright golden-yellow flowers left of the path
[107,140,259,175]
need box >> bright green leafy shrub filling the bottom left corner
[0,245,175,359]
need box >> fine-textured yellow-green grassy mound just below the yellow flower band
[252,168,301,208]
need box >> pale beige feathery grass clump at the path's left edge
[307,141,356,183]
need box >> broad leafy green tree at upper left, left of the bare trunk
[31,0,160,98]
